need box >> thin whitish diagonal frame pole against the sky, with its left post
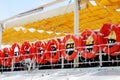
[0,0,70,46]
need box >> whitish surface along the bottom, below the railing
[0,67,120,80]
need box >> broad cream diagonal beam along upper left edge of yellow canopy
[5,3,74,28]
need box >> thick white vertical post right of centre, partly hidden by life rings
[74,0,79,67]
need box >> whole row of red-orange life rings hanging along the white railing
[0,23,120,66]
